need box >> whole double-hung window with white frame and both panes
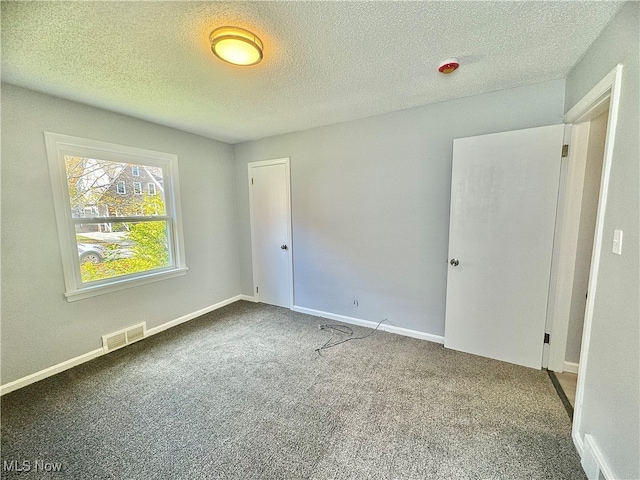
[45,132,187,301]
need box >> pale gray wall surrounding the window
[1,84,240,384]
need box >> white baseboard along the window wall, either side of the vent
[0,295,248,396]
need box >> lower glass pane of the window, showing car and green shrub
[76,220,172,282]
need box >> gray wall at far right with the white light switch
[565,2,640,478]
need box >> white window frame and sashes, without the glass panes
[44,132,188,302]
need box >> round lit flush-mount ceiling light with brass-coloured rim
[209,27,262,65]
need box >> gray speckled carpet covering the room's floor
[1,302,585,479]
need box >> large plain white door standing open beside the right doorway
[445,125,564,368]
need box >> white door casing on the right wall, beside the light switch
[564,64,622,455]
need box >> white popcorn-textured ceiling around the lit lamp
[2,1,622,143]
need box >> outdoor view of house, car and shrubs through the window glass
[64,155,172,283]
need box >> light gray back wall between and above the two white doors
[234,80,564,335]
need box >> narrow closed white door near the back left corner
[249,158,293,308]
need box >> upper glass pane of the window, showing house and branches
[64,155,165,218]
